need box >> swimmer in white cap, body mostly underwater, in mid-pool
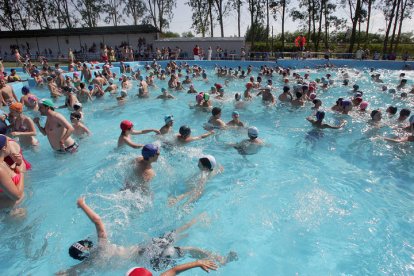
[168,155,224,206]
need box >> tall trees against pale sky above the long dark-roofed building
[0,0,176,32]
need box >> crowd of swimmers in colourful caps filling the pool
[0,53,414,275]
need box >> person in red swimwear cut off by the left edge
[0,135,24,209]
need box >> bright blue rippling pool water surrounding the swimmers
[0,61,414,275]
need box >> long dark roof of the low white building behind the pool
[0,24,159,38]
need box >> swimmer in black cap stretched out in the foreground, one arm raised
[56,197,237,275]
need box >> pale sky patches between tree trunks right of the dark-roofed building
[169,0,414,37]
